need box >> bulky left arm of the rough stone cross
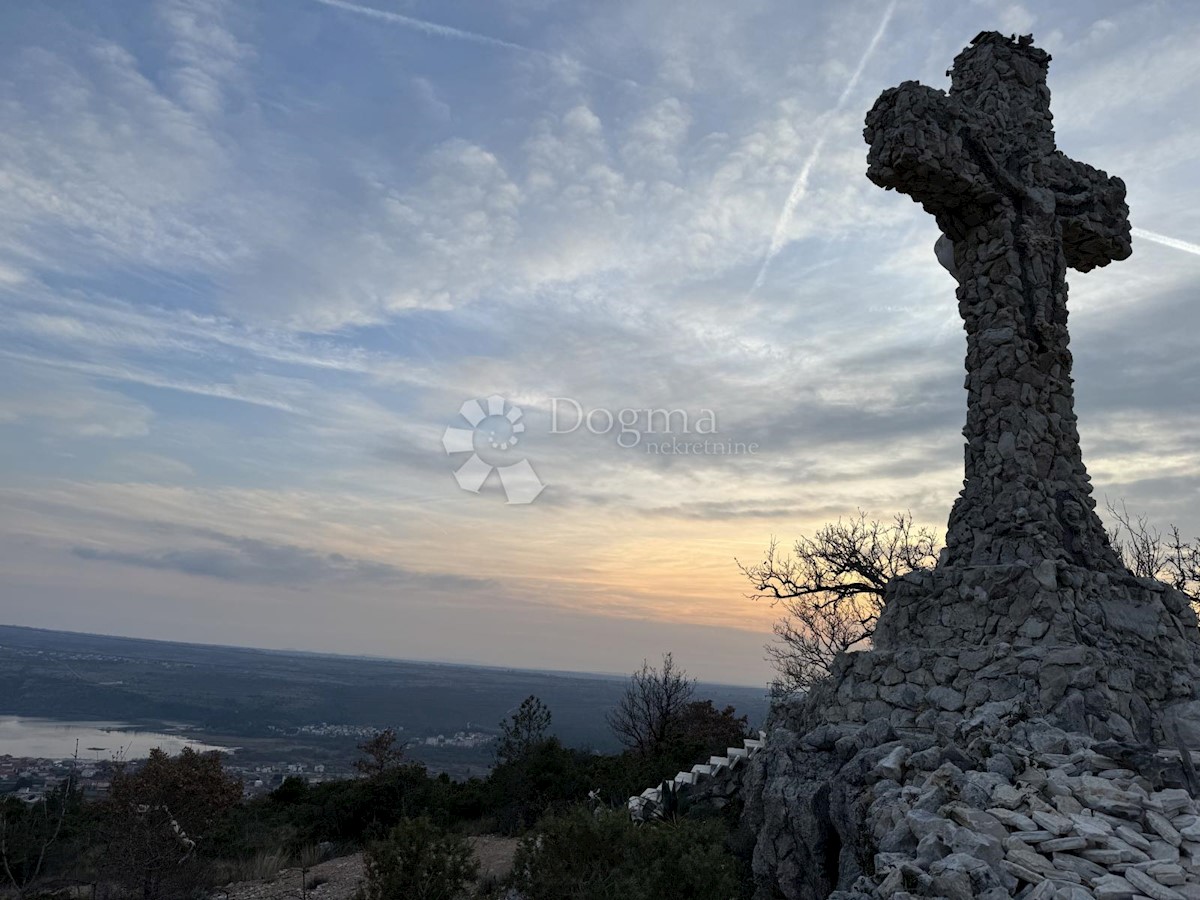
[863,82,1001,233]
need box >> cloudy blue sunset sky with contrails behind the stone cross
[0,0,1200,684]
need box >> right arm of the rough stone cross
[1046,151,1133,272]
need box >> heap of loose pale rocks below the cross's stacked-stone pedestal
[749,701,1200,900]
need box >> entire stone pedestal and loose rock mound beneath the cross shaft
[744,562,1200,900]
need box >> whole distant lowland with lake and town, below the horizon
[0,625,766,804]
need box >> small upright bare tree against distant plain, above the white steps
[608,653,696,756]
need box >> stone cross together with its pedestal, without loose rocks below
[854,32,1200,738]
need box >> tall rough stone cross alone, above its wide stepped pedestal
[864,31,1130,572]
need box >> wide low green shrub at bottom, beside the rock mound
[512,808,745,900]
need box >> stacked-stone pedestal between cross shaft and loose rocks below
[809,560,1200,740]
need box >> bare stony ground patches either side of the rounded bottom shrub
[212,834,517,900]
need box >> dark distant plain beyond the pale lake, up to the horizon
[0,625,767,775]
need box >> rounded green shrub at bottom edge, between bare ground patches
[359,818,479,900]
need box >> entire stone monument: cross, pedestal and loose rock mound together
[744,32,1200,900]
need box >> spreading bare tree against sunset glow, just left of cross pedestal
[738,510,940,692]
